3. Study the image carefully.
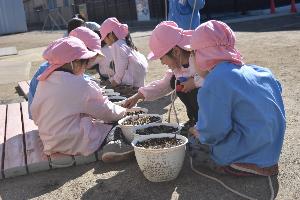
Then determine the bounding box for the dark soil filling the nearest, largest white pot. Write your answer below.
[136,137,183,149]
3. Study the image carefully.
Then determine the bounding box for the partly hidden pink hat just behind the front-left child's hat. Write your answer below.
[69,26,103,56]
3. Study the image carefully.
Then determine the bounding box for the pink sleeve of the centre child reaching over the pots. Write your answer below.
[139,70,174,101]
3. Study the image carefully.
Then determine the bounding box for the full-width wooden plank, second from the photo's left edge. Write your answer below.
[4,103,27,178]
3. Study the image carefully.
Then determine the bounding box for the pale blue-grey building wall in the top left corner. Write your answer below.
[0,0,27,35]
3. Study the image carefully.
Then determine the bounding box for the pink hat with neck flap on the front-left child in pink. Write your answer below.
[38,36,97,81]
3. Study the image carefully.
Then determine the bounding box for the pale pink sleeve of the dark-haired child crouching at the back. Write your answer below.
[109,41,129,84]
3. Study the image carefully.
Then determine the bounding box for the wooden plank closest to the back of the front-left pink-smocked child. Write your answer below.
[21,102,50,173]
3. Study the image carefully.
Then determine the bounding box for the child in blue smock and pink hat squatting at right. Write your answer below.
[191,20,286,176]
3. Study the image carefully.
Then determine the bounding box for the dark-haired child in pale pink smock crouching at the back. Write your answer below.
[100,17,148,87]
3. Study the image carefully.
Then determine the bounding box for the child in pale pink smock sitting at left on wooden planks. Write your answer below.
[30,36,132,161]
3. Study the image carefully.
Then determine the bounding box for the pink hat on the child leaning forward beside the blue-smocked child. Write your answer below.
[148,21,192,60]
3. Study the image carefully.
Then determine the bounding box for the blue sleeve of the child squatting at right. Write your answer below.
[196,87,232,145]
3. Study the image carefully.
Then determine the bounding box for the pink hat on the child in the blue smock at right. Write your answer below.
[191,20,244,71]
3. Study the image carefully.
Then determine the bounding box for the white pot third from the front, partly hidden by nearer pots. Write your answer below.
[118,114,162,142]
